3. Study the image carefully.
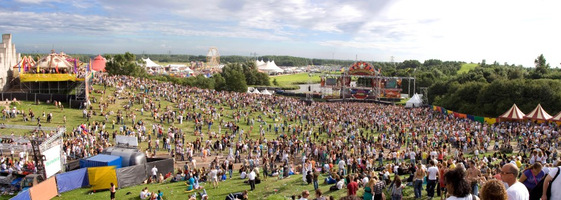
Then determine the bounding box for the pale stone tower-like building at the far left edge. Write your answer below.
[0,34,20,91]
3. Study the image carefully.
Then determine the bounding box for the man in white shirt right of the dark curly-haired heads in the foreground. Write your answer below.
[501,163,530,200]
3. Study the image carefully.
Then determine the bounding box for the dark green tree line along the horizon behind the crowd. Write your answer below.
[24,52,561,117]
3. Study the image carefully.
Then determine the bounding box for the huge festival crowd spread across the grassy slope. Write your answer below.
[1,75,561,199]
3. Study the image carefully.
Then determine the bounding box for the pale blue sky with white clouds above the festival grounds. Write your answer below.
[0,0,561,67]
